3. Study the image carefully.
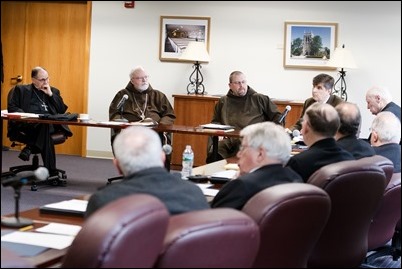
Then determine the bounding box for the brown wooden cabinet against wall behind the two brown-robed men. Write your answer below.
[171,94,303,166]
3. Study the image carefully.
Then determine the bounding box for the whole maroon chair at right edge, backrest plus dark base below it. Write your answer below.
[366,173,401,263]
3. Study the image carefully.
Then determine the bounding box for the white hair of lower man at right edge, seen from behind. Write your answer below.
[371,111,401,144]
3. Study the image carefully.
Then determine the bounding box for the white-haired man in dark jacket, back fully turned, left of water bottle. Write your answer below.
[86,126,209,217]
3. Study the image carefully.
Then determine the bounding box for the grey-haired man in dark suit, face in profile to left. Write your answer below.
[211,122,303,210]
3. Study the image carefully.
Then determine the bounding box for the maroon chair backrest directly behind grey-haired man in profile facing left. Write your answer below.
[242,183,331,268]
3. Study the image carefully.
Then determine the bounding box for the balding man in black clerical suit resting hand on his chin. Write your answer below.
[7,66,72,176]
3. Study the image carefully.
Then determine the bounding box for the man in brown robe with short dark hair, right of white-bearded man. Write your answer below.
[206,71,284,163]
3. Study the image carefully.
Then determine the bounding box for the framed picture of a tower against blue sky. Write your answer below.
[283,21,338,70]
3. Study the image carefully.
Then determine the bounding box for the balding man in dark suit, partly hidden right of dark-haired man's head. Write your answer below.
[335,102,376,159]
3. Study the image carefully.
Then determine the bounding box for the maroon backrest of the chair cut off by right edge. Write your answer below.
[368,173,401,251]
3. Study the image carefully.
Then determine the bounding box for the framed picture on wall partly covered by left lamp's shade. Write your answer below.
[159,16,211,62]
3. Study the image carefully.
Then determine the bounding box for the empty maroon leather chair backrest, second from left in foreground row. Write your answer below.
[155,208,260,268]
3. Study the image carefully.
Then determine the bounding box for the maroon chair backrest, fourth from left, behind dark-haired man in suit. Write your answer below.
[307,159,387,267]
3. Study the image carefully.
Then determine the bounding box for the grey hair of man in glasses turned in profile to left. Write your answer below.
[240,121,292,164]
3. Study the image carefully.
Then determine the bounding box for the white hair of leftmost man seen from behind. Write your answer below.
[113,126,164,176]
